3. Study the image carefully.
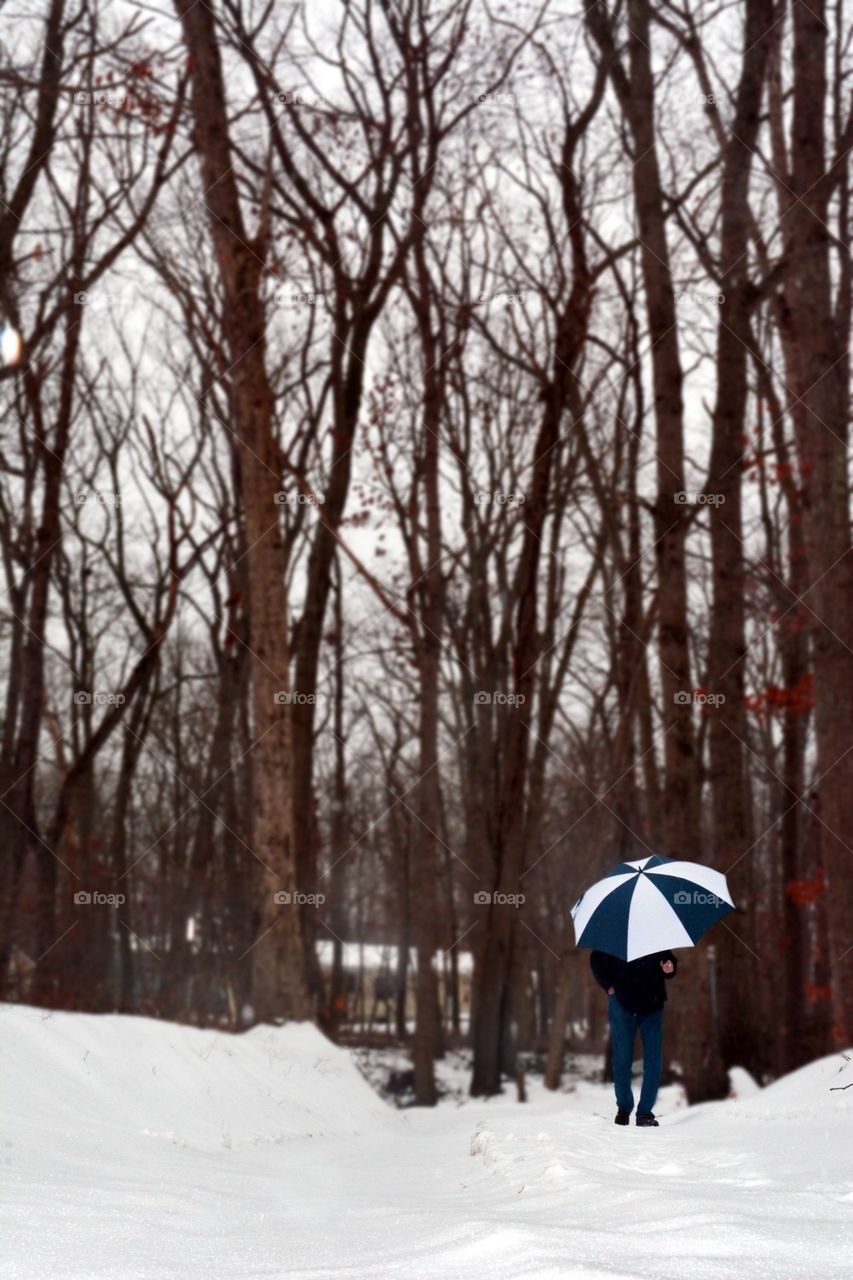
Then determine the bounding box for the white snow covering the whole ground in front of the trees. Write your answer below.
[0,1005,853,1280]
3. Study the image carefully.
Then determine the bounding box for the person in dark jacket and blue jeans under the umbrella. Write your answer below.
[589,951,679,1128]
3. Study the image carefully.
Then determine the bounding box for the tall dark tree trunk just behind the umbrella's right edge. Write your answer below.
[706,0,772,1097]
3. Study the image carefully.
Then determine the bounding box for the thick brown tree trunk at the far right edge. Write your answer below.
[785,0,853,1048]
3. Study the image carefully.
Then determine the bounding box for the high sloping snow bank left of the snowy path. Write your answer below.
[0,1005,394,1151]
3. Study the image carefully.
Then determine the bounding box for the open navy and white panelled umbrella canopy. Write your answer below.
[571,854,734,960]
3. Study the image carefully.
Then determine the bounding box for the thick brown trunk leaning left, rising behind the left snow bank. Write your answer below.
[175,0,311,1021]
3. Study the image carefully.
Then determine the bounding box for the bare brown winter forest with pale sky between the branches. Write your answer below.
[0,0,853,1106]
